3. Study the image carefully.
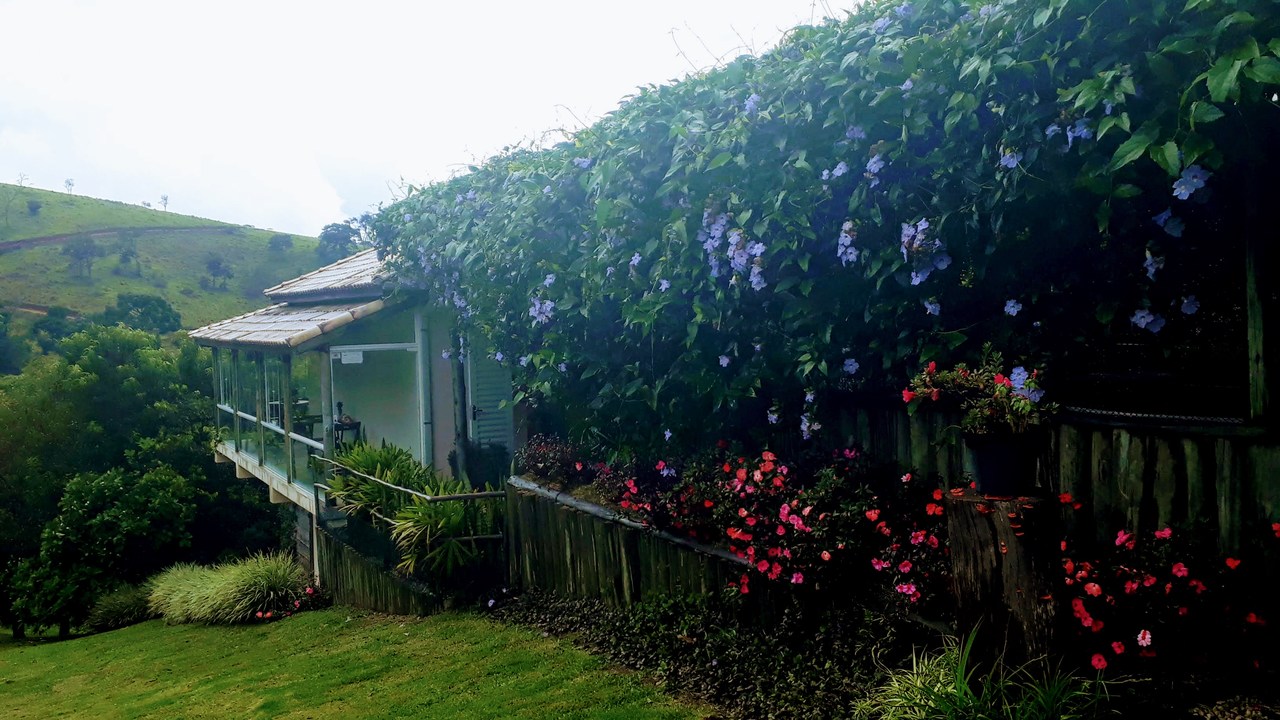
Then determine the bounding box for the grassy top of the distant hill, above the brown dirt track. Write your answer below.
[0,183,228,243]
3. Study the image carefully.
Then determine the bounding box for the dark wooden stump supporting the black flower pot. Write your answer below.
[947,491,1061,669]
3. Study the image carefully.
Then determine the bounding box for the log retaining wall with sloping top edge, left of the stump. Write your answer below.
[507,478,755,607]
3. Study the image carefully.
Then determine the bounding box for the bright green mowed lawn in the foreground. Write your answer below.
[0,607,705,720]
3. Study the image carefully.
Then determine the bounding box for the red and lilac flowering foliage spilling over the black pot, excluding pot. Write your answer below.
[902,345,1057,434]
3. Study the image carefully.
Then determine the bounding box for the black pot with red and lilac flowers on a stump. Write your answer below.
[902,345,1057,496]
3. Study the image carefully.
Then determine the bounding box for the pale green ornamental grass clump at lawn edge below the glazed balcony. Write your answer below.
[150,553,309,625]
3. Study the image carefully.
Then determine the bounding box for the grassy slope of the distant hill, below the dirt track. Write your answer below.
[0,225,320,328]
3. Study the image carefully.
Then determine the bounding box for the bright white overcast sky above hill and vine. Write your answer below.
[0,0,851,234]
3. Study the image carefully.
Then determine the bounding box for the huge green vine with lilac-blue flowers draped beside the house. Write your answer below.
[376,0,1280,454]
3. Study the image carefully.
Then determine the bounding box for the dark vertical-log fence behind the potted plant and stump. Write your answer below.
[842,407,1280,552]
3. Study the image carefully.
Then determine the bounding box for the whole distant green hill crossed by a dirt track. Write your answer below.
[0,183,321,328]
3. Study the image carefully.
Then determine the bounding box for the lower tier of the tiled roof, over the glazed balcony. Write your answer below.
[191,298,384,350]
